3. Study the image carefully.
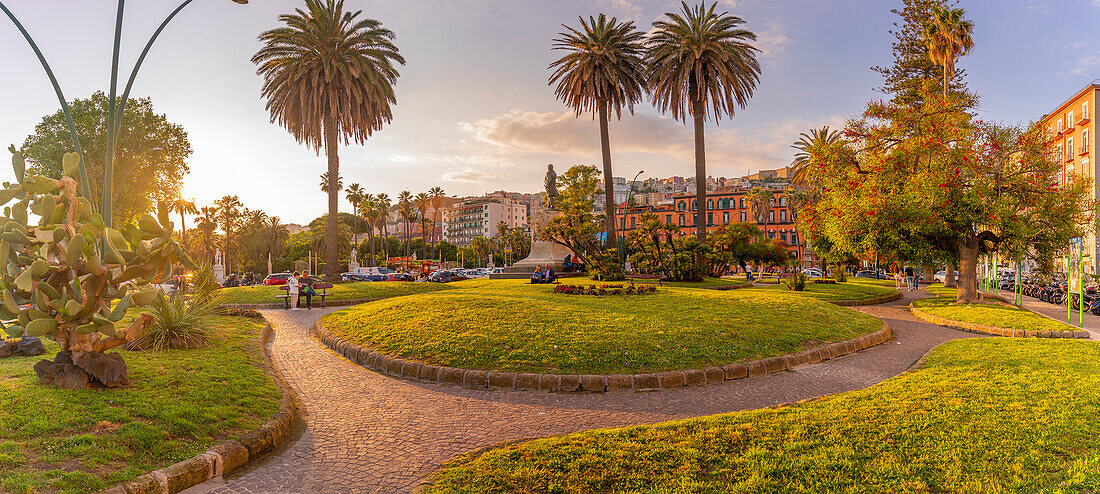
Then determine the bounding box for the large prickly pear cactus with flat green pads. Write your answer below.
[0,146,190,385]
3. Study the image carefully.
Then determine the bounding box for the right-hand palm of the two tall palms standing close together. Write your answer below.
[646,2,760,242]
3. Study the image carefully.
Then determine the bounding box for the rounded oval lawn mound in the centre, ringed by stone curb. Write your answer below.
[325,279,882,374]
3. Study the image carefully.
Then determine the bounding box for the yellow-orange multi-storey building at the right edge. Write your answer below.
[1040,79,1100,274]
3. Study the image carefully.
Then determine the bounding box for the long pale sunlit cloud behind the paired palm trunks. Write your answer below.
[461,110,844,176]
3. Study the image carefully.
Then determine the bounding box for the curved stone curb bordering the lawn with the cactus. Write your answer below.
[100,321,301,494]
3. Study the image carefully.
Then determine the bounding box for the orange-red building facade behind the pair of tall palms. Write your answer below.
[615,189,820,266]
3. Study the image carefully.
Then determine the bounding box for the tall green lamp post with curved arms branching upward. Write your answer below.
[0,0,249,227]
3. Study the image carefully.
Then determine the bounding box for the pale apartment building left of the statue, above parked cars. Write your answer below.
[442,193,528,246]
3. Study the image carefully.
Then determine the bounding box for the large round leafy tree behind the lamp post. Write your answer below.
[20,91,191,224]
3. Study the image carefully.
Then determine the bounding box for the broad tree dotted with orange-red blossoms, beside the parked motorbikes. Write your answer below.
[800,90,1097,303]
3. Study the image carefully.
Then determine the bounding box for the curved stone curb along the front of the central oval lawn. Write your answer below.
[309,319,891,393]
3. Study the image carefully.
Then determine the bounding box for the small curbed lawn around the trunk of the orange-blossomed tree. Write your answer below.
[913,286,1078,331]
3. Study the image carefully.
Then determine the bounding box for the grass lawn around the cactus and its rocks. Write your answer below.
[0,317,282,493]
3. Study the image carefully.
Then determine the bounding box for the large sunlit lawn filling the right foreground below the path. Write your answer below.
[427,336,1100,494]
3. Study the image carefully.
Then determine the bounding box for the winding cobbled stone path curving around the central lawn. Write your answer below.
[185,293,978,494]
